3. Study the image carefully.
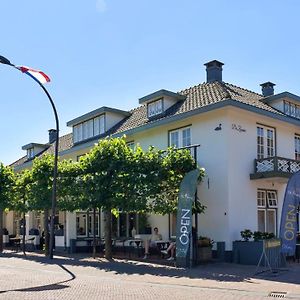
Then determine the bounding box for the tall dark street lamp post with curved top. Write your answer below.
[0,55,59,259]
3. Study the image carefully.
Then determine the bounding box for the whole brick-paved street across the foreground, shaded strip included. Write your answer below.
[0,252,300,300]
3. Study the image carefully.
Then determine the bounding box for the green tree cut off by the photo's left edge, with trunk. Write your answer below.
[0,163,15,252]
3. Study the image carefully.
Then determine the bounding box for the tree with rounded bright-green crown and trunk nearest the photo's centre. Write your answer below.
[79,138,134,259]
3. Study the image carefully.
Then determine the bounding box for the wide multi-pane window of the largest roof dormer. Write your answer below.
[73,114,105,143]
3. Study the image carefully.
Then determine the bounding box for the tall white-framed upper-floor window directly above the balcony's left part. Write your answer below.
[257,126,275,159]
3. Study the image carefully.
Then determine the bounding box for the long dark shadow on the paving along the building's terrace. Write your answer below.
[2,253,300,284]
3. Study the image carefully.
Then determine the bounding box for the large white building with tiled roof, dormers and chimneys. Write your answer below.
[7,60,300,258]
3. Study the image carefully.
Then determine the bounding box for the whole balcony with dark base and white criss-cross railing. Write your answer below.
[250,156,300,179]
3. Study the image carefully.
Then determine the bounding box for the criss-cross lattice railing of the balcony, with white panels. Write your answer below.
[254,156,300,174]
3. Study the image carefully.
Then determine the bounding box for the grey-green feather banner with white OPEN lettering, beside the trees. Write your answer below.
[176,169,200,267]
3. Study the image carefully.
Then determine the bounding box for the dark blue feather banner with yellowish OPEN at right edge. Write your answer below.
[280,171,300,256]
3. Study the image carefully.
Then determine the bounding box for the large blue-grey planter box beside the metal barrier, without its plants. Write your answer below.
[232,241,263,265]
